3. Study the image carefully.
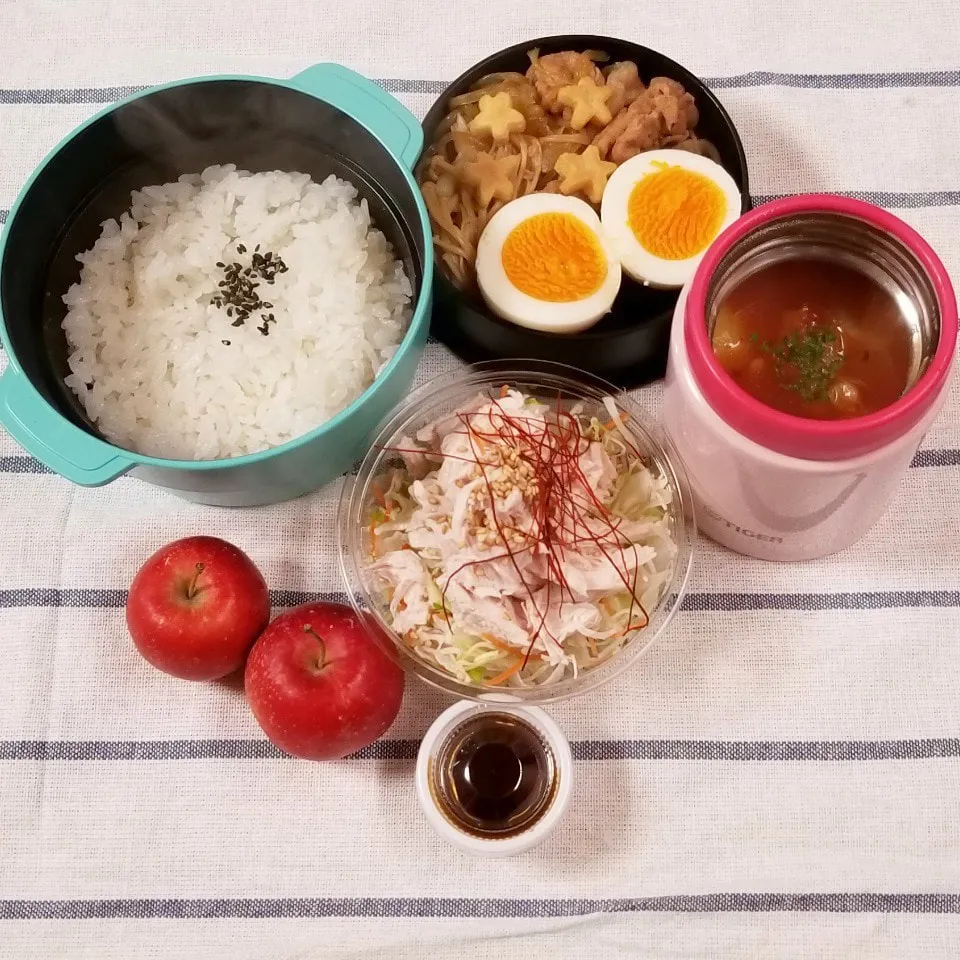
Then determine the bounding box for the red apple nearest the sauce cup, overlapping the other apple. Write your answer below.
[244,603,403,760]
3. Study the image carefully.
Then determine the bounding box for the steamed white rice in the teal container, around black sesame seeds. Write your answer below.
[63,165,412,460]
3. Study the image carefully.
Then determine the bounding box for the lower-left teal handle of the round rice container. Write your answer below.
[0,367,133,487]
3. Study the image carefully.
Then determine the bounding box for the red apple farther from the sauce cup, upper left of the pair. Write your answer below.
[127,537,270,680]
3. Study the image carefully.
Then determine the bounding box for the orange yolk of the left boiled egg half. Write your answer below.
[500,213,607,303]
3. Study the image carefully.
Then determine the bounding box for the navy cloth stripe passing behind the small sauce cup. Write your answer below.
[0,737,960,763]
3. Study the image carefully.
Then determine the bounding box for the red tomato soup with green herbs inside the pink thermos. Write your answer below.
[712,258,913,420]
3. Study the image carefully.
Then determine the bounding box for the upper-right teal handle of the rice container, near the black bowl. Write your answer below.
[290,63,423,170]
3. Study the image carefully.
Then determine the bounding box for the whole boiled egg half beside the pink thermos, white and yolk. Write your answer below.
[600,150,741,287]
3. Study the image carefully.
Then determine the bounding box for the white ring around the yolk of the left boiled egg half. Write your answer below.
[476,193,621,333]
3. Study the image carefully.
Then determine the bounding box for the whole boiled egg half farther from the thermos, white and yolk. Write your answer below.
[477,193,621,333]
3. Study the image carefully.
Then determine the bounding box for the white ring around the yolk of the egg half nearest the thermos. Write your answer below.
[600,150,741,288]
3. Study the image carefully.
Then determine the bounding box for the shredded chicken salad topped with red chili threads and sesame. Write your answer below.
[371,390,676,685]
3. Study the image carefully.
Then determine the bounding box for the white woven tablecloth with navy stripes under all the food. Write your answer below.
[0,0,960,960]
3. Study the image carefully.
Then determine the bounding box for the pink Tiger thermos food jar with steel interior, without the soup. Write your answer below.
[663,195,957,560]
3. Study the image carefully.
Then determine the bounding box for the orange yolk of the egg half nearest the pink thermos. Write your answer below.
[627,164,727,260]
